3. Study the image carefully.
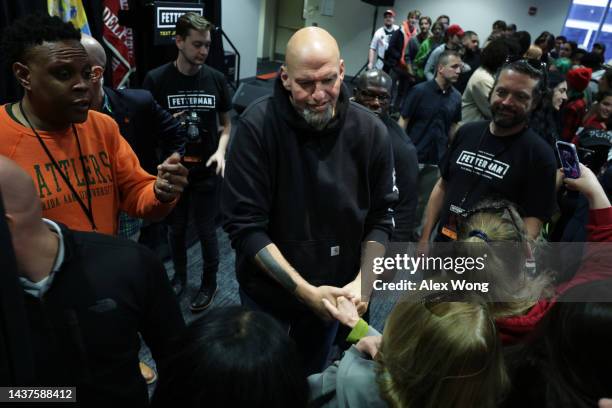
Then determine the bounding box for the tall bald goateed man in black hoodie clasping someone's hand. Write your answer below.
[221,27,397,373]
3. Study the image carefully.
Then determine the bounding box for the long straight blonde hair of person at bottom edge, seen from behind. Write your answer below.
[377,301,509,408]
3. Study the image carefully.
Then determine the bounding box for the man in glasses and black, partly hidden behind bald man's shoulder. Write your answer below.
[353,69,419,242]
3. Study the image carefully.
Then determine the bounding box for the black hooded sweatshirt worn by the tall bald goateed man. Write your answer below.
[221,79,396,314]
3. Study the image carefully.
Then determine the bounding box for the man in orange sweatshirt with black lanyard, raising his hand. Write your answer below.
[0,16,188,234]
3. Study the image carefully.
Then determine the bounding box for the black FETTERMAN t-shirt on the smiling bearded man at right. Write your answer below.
[439,121,557,236]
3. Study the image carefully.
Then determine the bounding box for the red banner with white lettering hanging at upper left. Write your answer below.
[102,0,136,88]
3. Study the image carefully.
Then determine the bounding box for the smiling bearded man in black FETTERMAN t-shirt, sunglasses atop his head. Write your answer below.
[421,60,557,248]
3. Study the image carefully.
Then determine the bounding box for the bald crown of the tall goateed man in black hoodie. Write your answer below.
[285,27,340,72]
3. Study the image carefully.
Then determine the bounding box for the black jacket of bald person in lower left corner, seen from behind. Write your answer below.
[24,226,185,407]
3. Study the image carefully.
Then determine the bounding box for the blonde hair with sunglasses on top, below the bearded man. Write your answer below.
[458,200,554,318]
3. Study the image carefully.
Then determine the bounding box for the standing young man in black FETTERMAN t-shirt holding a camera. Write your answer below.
[143,13,231,312]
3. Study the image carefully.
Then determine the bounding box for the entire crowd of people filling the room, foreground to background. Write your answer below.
[0,10,612,408]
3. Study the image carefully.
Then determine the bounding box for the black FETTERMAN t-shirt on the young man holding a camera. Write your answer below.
[143,62,231,176]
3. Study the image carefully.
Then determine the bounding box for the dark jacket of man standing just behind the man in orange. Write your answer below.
[104,86,185,175]
